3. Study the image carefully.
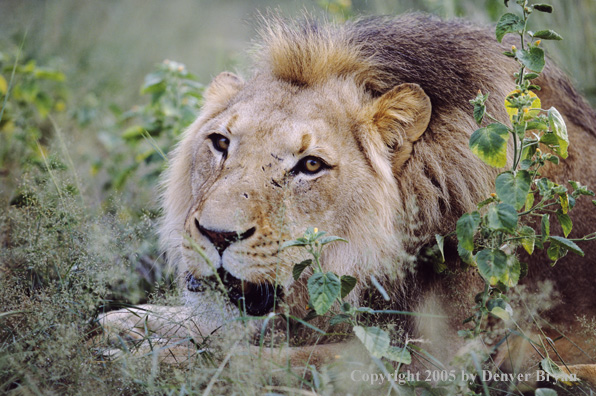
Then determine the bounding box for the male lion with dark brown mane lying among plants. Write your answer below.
[102,14,596,381]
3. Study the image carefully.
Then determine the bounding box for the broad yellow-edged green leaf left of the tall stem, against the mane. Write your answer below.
[470,123,509,168]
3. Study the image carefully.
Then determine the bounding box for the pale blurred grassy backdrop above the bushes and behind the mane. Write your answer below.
[0,0,596,105]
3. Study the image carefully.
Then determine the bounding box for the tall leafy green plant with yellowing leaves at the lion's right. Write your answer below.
[436,0,596,384]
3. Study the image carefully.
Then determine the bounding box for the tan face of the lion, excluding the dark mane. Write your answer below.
[166,73,429,314]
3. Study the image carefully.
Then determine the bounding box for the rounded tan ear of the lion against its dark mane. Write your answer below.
[372,84,432,171]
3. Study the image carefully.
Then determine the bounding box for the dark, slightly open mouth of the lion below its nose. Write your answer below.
[186,267,282,316]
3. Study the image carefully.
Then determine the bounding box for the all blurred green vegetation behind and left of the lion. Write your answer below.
[0,0,596,394]
